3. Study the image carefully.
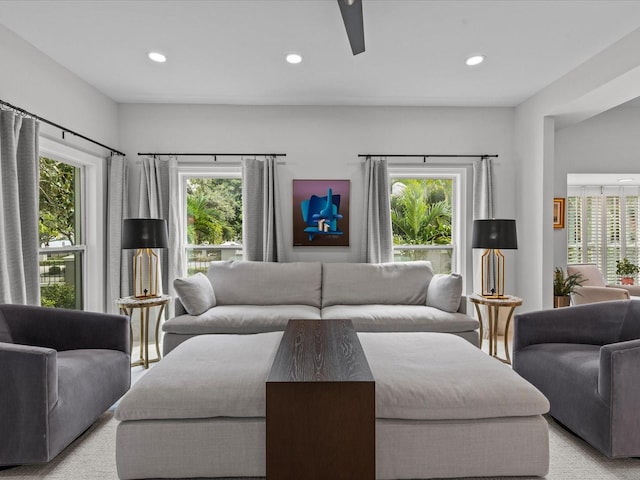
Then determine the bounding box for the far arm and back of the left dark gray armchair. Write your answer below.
[0,305,130,353]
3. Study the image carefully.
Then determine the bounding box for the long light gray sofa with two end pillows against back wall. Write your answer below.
[162,261,479,355]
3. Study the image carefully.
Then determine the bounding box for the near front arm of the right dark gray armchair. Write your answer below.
[598,340,640,457]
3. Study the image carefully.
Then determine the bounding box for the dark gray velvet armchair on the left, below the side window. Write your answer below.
[0,305,131,466]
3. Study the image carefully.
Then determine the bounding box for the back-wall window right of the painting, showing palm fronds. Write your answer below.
[389,167,465,273]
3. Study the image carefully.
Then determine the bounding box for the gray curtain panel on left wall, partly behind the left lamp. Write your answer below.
[105,154,132,313]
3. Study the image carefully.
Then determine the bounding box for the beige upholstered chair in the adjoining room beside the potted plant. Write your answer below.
[567,263,640,305]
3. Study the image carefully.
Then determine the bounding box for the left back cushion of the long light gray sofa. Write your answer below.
[207,261,322,308]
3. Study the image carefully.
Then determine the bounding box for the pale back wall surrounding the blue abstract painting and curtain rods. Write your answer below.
[119,104,517,284]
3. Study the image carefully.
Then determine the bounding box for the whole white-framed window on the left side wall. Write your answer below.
[39,139,105,312]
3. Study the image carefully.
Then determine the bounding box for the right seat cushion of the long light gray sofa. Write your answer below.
[322,304,480,333]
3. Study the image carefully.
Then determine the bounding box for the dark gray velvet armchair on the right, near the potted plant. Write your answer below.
[513,300,640,458]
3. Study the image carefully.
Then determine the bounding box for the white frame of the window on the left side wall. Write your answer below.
[38,135,106,312]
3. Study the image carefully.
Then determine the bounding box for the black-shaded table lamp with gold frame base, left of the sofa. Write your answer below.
[122,218,169,298]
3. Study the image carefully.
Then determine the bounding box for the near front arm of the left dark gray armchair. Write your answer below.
[0,343,58,465]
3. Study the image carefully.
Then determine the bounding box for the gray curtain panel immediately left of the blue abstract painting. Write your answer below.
[242,157,284,262]
